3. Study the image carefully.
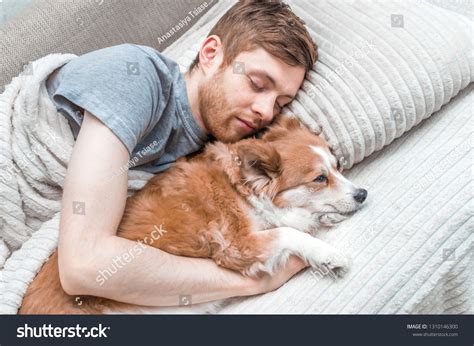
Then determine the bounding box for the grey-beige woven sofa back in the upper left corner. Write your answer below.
[0,0,217,92]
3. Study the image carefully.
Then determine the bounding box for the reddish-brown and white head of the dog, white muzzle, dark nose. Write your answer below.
[234,116,367,224]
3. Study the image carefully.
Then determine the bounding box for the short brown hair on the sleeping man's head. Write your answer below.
[189,0,318,72]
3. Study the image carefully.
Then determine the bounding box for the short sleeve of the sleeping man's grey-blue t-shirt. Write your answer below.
[54,44,167,155]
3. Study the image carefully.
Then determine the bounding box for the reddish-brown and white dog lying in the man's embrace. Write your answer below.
[19,116,367,314]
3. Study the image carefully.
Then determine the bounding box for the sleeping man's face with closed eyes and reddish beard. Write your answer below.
[198,48,305,142]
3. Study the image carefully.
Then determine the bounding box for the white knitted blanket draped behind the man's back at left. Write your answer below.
[0,54,152,314]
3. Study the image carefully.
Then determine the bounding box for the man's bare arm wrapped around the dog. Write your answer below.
[59,111,305,306]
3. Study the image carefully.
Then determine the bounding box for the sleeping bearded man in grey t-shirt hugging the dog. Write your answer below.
[51,1,317,306]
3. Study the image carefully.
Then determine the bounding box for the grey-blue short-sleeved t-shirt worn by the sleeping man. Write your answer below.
[46,44,208,173]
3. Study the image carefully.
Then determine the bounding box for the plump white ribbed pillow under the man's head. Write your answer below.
[165,0,474,169]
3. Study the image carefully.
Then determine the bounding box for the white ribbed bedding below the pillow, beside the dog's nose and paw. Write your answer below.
[221,84,474,314]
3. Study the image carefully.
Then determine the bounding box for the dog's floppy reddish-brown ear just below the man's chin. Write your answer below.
[237,141,282,198]
